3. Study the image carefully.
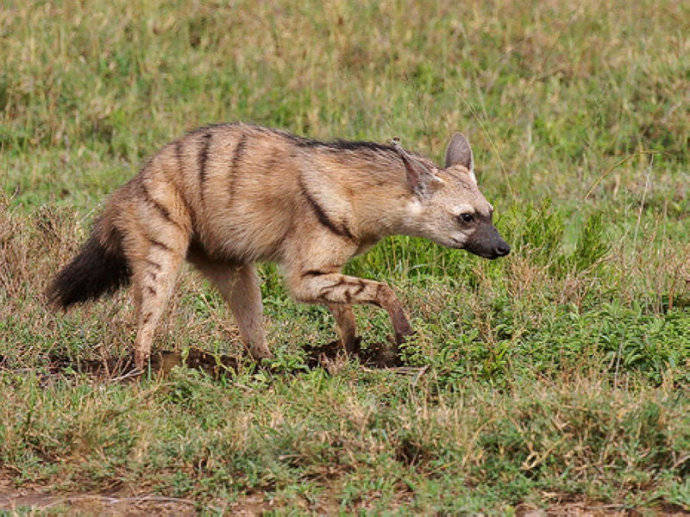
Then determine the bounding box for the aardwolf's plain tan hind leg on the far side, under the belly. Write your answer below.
[192,257,273,361]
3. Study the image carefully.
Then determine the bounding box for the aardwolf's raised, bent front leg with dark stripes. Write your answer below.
[288,270,412,344]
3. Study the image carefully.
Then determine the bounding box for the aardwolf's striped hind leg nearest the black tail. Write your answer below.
[130,237,186,370]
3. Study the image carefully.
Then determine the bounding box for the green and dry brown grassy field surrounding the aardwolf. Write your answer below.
[0,0,690,513]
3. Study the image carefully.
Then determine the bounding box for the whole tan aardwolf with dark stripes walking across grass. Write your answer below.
[48,123,510,369]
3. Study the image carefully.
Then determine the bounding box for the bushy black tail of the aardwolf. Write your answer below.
[47,224,131,309]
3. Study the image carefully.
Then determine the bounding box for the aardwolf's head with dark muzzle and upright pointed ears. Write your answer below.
[393,133,510,259]
